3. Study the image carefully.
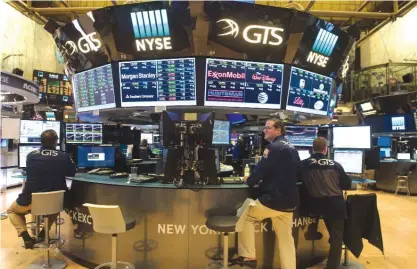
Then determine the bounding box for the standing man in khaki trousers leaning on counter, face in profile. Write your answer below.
[238,118,301,269]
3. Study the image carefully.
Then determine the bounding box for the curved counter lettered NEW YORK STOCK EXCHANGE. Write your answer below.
[61,174,329,269]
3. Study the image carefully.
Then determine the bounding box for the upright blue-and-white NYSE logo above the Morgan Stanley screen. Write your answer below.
[130,9,172,51]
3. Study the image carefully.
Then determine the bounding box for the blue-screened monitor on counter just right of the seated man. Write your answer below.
[77,146,116,168]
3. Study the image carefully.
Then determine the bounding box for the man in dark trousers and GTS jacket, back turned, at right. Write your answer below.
[302,137,352,269]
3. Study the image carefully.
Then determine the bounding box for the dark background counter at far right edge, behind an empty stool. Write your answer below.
[375,160,417,195]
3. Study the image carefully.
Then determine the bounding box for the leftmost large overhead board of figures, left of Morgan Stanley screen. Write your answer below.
[73,64,116,112]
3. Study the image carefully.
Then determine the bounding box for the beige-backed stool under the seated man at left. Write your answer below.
[28,190,67,269]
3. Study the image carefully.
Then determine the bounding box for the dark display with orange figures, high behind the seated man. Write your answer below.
[33,70,73,105]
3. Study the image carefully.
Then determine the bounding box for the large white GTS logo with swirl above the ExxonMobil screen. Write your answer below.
[216,19,284,46]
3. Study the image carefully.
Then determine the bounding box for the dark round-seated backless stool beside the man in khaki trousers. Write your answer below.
[206,216,239,269]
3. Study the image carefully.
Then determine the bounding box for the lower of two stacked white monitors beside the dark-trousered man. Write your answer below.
[334,149,363,174]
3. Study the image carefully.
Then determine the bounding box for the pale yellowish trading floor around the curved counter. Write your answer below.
[0,188,417,269]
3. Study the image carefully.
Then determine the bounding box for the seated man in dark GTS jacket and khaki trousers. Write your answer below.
[7,130,76,248]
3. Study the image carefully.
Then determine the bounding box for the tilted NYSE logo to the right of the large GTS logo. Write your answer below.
[307,29,339,67]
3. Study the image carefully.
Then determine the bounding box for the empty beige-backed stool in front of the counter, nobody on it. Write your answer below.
[83,203,136,269]
